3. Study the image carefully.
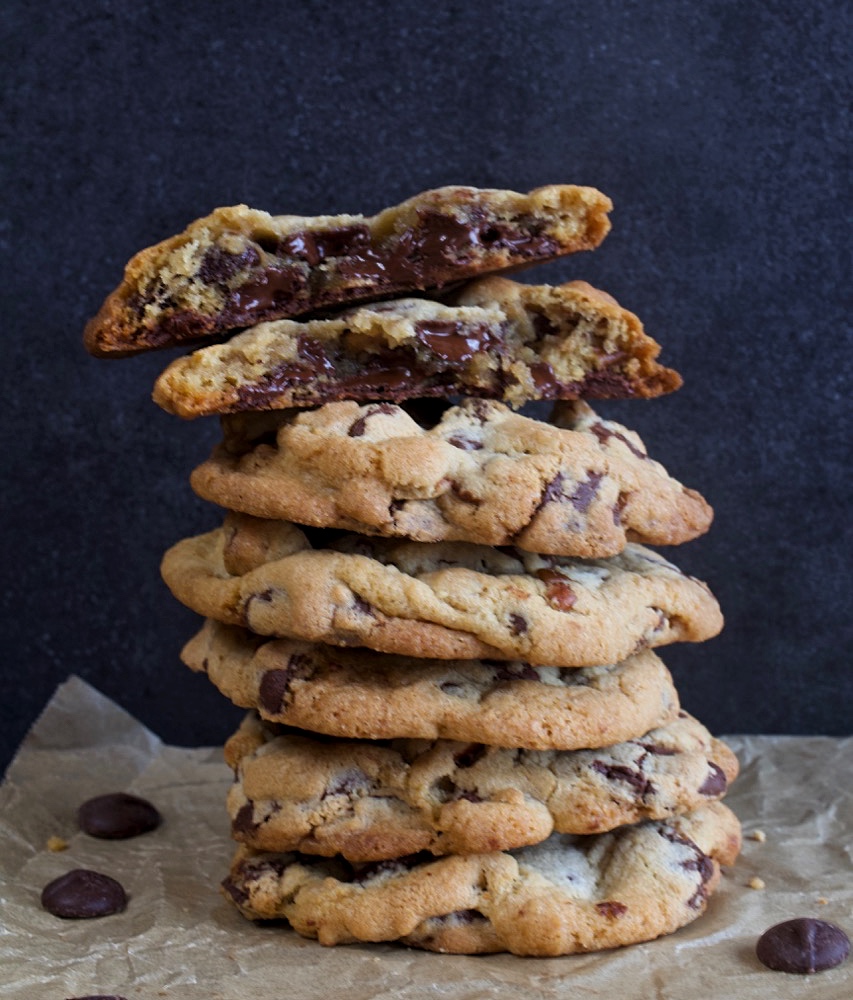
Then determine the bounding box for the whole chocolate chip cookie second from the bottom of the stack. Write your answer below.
[225,714,737,861]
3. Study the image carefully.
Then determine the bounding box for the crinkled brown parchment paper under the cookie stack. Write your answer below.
[0,677,853,1000]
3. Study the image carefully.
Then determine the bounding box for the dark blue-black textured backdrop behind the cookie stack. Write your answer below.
[0,0,853,763]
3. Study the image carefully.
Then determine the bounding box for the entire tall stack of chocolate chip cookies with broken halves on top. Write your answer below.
[86,185,740,955]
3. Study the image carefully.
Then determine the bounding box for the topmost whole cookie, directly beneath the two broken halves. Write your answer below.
[191,399,713,558]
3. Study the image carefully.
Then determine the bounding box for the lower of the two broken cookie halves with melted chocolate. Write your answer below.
[148,278,681,418]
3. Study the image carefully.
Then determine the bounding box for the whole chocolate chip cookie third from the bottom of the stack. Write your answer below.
[181,620,679,750]
